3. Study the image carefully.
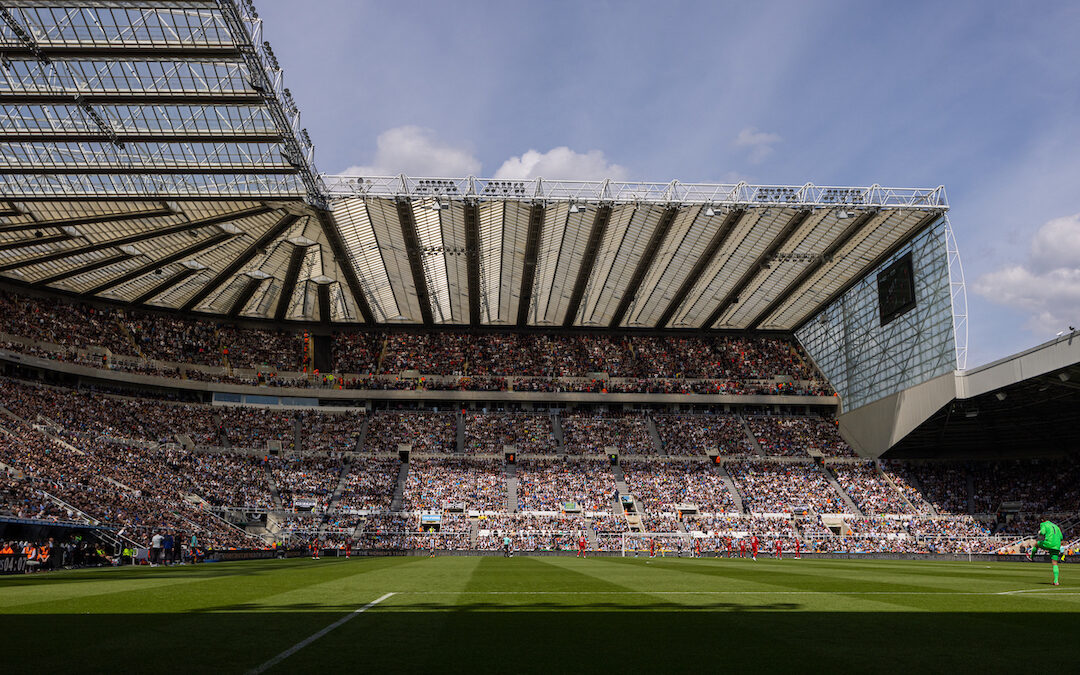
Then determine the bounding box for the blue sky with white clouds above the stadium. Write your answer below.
[257,0,1080,366]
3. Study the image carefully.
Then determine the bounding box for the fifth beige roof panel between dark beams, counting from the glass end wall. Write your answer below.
[575,204,664,326]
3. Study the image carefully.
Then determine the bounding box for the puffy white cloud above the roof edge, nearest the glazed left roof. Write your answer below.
[343,126,481,177]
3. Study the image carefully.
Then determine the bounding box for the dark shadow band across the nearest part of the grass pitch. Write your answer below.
[0,603,1080,674]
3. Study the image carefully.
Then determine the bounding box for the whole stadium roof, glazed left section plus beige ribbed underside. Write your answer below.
[0,0,948,330]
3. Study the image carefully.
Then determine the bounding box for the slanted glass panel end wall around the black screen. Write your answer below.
[795,218,956,410]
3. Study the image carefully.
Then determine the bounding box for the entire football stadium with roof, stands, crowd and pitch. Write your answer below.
[0,0,1080,673]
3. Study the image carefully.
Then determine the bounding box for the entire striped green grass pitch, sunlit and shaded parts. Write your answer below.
[0,556,1080,673]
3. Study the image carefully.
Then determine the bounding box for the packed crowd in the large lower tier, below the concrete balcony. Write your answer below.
[0,371,1080,551]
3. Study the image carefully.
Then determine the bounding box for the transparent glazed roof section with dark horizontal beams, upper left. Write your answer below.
[0,0,318,199]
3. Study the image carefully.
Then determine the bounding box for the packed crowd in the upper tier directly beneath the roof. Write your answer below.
[0,291,832,395]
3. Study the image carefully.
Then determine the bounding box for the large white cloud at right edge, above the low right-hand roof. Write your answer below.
[973,214,1080,337]
